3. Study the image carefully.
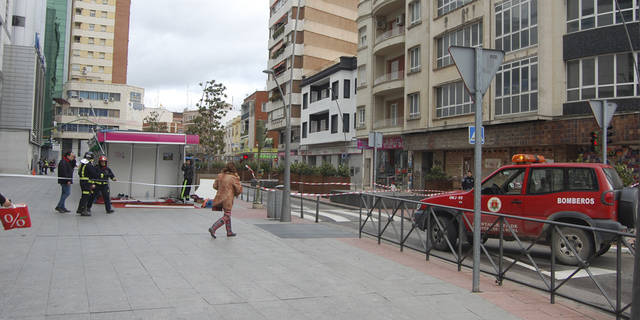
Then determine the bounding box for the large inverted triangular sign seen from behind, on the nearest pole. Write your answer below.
[449,46,504,98]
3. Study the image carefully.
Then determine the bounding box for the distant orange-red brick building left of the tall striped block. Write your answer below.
[240,91,279,159]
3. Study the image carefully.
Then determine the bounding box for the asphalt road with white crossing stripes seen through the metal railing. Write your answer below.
[291,194,634,316]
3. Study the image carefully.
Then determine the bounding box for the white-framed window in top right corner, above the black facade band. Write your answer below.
[567,0,640,33]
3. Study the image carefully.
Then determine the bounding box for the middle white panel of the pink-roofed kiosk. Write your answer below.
[131,144,156,200]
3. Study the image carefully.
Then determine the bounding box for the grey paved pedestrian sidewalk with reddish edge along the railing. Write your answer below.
[0,177,610,320]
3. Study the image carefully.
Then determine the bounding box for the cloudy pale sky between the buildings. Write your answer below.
[128,0,269,117]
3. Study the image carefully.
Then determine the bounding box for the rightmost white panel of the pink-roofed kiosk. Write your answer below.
[156,145,183,198]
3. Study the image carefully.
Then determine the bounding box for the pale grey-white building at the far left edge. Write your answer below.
[0,0,46,173]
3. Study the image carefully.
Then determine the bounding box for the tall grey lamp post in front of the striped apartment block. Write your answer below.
[280,0,300,222]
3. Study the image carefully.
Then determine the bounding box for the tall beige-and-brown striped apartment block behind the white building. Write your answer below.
[266,0,358,164]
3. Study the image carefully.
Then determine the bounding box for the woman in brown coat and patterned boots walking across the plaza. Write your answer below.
[209,162,242,239]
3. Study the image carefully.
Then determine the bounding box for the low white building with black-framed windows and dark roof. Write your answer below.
[300,57,362,173]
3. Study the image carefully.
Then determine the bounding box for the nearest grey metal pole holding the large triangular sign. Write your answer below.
[472,48,482,292]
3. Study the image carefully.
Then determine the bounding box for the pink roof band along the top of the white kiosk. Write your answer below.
[98,131,200,145]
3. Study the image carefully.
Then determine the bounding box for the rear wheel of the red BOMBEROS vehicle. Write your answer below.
[552,227,594,266]
